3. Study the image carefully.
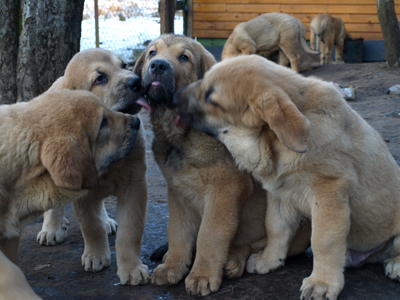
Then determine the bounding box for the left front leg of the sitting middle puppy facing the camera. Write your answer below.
[150,186,200,285]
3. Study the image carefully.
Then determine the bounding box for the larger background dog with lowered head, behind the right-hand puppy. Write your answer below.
[222,13,320,72]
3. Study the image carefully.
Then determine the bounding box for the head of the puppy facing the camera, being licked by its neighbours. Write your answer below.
[133,34,216,108]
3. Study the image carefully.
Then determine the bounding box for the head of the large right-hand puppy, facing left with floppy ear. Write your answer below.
[174,55,310,152]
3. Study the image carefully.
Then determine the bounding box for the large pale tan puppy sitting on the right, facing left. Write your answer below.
[174,55,400,300]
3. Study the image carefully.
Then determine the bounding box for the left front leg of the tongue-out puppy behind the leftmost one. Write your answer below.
[72,193,110,272]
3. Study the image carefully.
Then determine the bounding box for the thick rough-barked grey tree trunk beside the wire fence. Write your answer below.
[17,0,84,102]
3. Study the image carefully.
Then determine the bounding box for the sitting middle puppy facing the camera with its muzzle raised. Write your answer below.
[134,34,310,296]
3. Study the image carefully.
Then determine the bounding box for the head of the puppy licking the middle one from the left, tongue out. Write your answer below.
[49,48,142,114]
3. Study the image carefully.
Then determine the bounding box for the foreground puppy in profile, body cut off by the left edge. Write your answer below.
[0,90,140,299]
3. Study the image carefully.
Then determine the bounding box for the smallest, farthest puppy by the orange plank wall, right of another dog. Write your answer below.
[310,14,351,65]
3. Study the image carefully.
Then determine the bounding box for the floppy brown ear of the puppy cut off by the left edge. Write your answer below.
[40,137,98,191]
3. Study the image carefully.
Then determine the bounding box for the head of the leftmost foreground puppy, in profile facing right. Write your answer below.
[39,90,140,190]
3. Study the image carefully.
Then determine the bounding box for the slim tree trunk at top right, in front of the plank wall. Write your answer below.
[377,0,400,68]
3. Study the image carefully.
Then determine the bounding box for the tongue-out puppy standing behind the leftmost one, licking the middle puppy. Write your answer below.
[38,49,150,285]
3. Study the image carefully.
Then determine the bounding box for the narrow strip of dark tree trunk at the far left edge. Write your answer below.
[0,0,19,104]
